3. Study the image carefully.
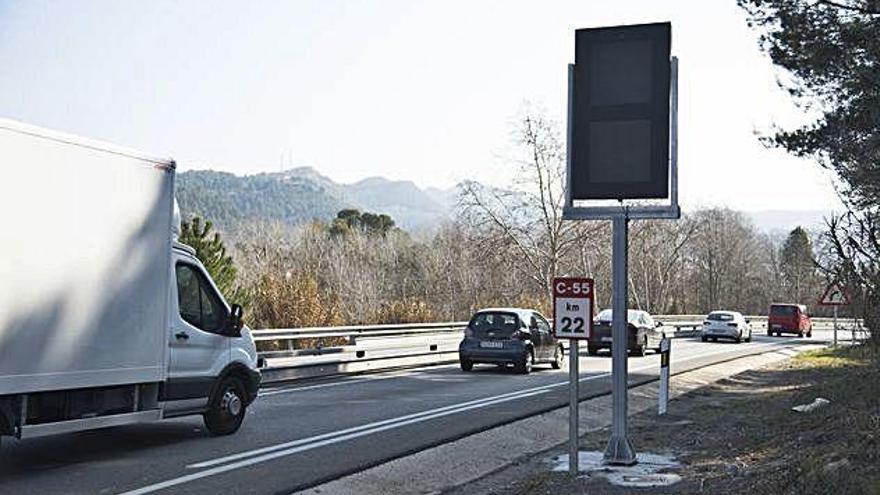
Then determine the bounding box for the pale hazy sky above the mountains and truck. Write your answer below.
[0,0,837,210]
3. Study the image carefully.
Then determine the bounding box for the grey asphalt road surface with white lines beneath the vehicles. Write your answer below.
[0,331,844,495]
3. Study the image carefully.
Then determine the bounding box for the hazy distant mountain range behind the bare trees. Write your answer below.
[177,167,830,235]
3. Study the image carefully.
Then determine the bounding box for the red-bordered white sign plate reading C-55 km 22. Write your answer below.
[553,277,595,339]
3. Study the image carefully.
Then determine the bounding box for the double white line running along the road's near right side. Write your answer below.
[120,338,800,495]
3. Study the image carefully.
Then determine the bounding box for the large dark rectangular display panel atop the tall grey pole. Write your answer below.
[569,22,672,200]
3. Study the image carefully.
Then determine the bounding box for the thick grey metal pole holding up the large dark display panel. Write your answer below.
[604,213,636,466]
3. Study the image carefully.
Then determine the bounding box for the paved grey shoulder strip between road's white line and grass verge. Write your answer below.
[299,349,824,495]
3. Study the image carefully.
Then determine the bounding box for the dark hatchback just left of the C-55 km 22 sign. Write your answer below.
[458,308,565,373]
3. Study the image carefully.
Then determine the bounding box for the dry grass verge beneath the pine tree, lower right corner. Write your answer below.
[450,346,880,495]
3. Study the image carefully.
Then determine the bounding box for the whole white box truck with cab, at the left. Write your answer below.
[0,119,260,448]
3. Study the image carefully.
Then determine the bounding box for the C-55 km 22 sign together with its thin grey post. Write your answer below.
[553,278,594,477]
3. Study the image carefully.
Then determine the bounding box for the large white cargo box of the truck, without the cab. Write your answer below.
[0,119,174,395]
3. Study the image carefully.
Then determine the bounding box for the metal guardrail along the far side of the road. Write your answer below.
[253,315,853,383]
